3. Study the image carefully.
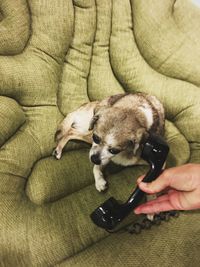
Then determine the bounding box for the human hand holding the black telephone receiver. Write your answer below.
[134,164,200,214]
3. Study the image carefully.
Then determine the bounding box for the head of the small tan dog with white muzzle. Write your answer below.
[90,106,148,165]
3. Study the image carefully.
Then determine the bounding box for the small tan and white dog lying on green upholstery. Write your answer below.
[53,93,165,194]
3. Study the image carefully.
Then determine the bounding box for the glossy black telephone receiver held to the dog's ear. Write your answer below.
[90,134,169,231]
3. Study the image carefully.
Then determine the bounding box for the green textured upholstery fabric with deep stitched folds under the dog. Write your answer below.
[0,0,200,267]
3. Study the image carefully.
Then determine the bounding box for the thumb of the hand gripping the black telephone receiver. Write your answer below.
[138,172,170,194]
